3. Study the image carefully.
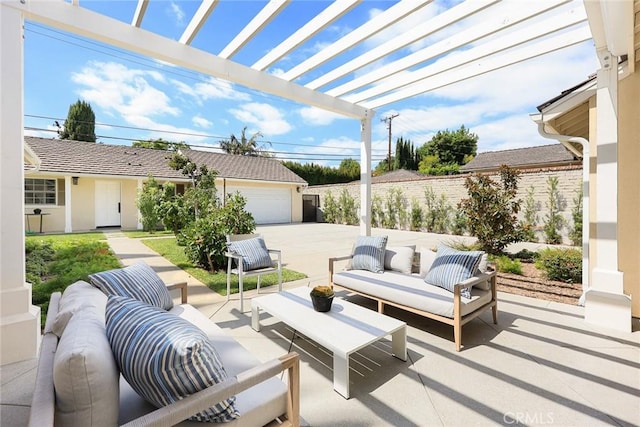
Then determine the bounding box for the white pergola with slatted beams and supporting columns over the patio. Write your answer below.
[0,0,635,364]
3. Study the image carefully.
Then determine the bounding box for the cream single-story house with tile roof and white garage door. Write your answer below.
[24,136,307,232]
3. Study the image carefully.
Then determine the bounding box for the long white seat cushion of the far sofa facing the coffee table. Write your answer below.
[333,270,491,318]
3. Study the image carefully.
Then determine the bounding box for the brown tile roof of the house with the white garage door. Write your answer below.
[24,136,306,184]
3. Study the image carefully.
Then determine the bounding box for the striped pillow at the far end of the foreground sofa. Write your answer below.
[89,262,173,310]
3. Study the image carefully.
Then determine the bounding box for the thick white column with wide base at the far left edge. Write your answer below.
[0,3,40,365]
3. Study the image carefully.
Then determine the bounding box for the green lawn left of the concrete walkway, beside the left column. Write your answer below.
[25,232,120,326]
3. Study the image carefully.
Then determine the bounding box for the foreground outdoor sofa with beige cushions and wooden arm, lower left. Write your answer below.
[29,264,299,427]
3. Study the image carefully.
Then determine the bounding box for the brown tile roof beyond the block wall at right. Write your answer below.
[460,144,581,172]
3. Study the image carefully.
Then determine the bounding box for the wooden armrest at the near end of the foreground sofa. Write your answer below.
[125,352,300,427]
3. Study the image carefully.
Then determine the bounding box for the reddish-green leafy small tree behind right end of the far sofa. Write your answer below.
[458,165,522,254]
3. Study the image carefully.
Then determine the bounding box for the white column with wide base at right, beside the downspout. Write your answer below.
[585,49,631,332]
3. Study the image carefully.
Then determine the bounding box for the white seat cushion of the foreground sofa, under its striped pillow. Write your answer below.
[119,304,287,427]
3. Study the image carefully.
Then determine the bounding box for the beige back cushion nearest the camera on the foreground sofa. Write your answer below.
[53,308,120,426]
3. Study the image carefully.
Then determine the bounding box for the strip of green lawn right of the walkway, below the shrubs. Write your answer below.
[143,238,307,295]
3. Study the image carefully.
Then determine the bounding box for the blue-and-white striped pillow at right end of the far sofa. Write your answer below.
[424,245,484,298]
